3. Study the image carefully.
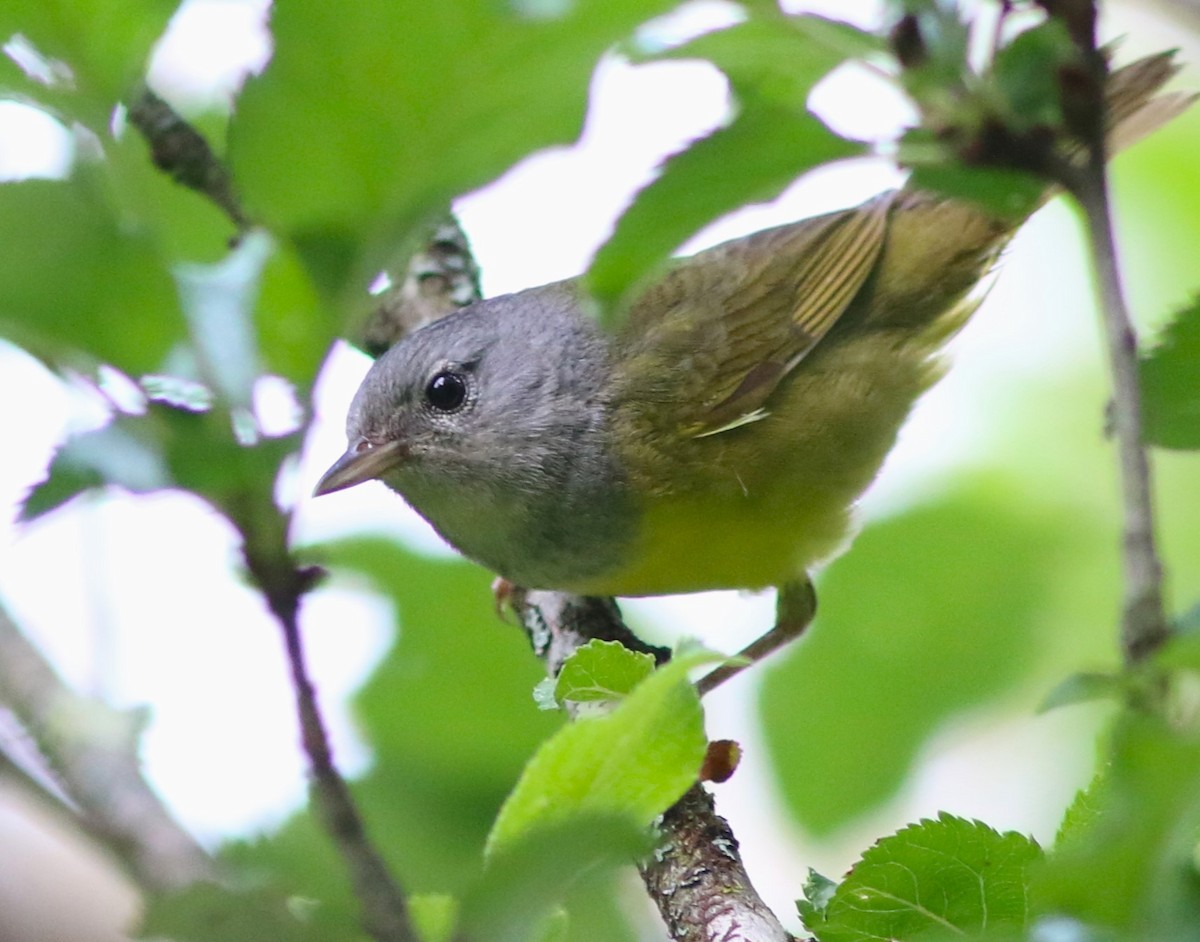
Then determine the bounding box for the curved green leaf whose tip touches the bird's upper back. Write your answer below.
[586,101,860,320]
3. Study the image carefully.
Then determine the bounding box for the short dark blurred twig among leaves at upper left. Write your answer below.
[128,89,250,233]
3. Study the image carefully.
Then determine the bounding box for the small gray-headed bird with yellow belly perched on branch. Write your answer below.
[314,55,1175,685]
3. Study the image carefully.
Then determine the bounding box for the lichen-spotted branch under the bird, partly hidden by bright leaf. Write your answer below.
[509,589,793,942]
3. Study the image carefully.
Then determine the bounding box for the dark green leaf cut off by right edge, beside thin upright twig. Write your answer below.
[1139,299,1200,449]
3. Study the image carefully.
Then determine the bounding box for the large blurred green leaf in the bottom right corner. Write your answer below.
[1033,713,1200,942]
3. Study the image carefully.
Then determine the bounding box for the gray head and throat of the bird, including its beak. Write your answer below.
[317,283,631,588]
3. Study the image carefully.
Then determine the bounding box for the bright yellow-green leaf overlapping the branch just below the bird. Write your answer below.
[487,653,714,856]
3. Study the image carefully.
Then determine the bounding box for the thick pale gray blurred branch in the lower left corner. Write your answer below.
[0,610,215,890]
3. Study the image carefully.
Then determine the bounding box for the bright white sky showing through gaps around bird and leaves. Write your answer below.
[0,0,1180,912]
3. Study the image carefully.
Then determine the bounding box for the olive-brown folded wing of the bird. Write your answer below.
[613,193,894,438]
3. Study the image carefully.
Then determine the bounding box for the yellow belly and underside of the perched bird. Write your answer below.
[566,326,938,595]
